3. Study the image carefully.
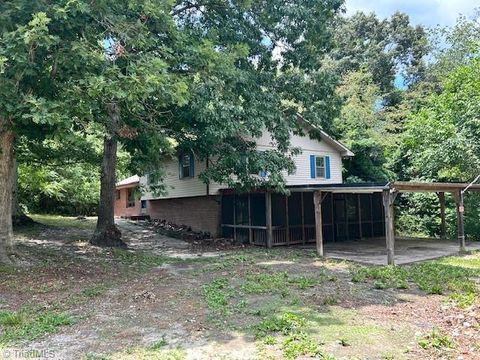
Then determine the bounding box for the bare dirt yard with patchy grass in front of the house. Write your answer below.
[0,219,480,359]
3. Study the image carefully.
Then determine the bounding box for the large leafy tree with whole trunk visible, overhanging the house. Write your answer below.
[66,0,340,245]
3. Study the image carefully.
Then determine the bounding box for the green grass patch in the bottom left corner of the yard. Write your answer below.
[0,309,74,344]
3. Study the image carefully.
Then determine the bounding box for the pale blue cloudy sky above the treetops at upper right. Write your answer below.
[346,0,480,27]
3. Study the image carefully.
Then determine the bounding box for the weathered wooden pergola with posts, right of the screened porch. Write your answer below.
[310,182,480,265]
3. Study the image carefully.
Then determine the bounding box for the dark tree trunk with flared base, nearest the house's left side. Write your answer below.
[90,103,126,247]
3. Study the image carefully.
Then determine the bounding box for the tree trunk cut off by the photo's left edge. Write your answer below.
[0,117,15,263]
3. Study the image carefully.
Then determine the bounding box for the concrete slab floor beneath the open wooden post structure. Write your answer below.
[324,239,480,265]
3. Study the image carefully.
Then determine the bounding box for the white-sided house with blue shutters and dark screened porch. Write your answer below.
[115,123,385,246]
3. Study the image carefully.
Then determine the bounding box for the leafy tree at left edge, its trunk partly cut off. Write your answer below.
[0,1,68,261]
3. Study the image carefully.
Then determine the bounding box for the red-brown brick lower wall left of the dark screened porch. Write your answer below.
[147,196,220,236]
